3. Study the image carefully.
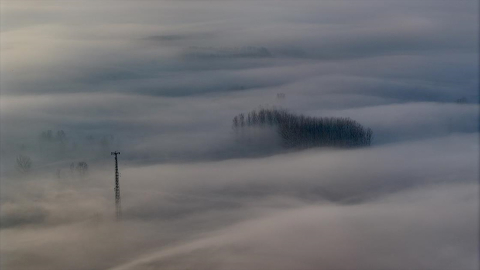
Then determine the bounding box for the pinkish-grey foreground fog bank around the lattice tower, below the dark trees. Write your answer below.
[2,135,478,269]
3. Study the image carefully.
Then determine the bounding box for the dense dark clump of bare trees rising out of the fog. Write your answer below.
[233,109,372,148]
